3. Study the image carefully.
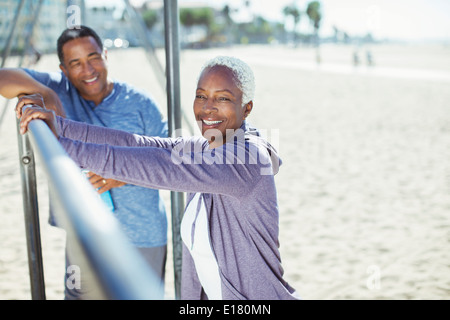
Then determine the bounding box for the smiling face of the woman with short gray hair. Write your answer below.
[194,66,253,149]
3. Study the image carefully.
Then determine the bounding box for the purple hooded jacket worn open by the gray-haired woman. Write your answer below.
[57,117,296,300]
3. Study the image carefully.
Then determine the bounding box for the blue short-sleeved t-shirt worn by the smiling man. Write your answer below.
[24,69,168,247]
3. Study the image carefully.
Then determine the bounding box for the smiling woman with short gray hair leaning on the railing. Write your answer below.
[17,57,296,299]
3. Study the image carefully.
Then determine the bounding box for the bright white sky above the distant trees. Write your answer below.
[102,0,450,41]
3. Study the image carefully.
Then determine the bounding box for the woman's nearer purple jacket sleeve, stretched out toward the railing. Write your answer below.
[60,130,261,198]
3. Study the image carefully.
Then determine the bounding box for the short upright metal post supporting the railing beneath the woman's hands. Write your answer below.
[17,122,45,300]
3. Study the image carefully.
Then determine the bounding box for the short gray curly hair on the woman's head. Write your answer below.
[200,56,255,106]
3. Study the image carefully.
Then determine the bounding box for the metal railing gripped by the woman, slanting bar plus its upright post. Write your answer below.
[19,115,161,300]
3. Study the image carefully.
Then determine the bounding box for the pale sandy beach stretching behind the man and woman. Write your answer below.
[0,45,450,300]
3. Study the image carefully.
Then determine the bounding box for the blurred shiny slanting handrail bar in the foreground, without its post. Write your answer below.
[27,120,161,300]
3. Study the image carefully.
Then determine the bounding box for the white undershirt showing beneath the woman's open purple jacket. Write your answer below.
[180,193,222,300]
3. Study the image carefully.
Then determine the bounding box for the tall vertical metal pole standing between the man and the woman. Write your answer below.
[164,0,184,300]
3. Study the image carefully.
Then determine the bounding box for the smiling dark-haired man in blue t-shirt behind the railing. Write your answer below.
[0,26,167,299]
